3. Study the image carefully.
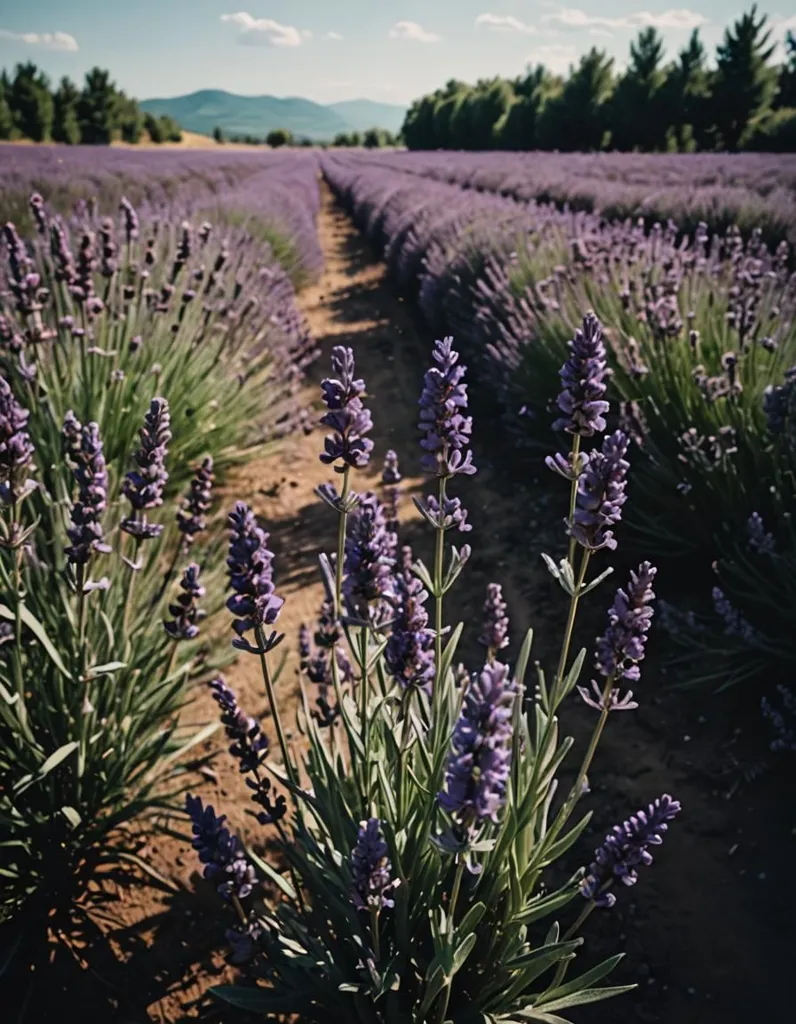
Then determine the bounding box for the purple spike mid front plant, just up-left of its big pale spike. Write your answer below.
[384,565,435,688]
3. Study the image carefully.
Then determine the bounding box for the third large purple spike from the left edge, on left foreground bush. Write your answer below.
[120,398,171,540]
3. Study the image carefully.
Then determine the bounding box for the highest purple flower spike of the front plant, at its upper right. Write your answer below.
[553,312,609,437]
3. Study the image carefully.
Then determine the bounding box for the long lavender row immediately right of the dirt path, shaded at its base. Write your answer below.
[324,149,796,712]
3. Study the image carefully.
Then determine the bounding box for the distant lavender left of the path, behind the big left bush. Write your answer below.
[0,145,323,283]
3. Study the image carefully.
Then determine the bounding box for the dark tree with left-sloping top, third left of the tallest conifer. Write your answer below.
[538,47,614,152]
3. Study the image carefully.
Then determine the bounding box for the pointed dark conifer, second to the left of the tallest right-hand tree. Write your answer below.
[611,28,668,152]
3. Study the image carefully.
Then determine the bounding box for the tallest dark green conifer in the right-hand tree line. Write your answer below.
[712,4,777,151]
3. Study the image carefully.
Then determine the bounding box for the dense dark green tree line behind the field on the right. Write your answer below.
[402,5,796,153]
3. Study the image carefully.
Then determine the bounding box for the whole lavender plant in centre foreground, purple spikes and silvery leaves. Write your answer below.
[187,319,680,1024]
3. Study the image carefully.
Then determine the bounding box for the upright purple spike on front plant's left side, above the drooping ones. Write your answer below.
[226,502,285,650]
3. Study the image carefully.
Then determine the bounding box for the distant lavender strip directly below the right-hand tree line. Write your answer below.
[350,152,796,246]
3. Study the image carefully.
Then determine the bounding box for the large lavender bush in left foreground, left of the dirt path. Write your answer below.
[0,160,318,924]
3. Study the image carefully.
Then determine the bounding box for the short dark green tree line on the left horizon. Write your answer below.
[0,61,182,145]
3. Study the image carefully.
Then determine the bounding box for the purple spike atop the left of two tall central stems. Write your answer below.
[321,345,373,473]
